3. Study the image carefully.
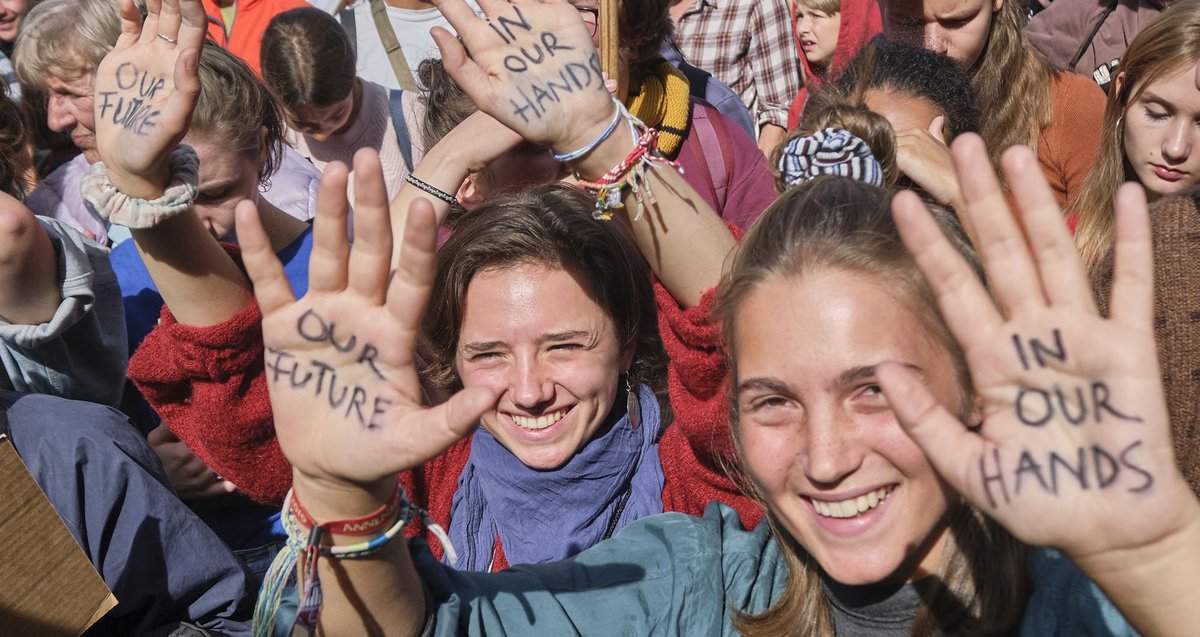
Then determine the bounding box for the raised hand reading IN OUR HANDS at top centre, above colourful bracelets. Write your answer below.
[433,0,613,152]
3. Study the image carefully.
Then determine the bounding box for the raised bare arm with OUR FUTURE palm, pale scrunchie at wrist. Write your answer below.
[95,0,250,326]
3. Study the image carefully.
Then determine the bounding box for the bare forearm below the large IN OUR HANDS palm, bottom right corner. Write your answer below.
[1075,503,1200,637]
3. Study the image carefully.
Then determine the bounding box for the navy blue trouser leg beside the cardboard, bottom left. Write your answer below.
[0,391,256,637]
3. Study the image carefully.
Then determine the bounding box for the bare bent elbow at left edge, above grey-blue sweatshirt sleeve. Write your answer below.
[0,209,62,325]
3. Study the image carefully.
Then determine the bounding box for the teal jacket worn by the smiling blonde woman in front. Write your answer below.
[400,503,1135,637]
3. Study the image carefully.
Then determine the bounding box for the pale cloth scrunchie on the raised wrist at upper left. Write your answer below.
[80,144,200,229]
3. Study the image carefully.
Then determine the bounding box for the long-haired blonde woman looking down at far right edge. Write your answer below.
[1070,0,1200,266]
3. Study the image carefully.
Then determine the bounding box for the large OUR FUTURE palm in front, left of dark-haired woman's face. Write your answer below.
[238,150,496,504]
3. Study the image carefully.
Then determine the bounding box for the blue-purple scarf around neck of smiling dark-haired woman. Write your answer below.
[450,385,662,571]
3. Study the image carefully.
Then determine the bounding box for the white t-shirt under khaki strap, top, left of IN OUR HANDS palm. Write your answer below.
[324,0,482,89]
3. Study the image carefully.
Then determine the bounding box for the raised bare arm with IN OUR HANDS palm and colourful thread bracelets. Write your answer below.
[433,0,734,306]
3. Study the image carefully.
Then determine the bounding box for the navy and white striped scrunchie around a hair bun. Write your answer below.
[779,128,883,186]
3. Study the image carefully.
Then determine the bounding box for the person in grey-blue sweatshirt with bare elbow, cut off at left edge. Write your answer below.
[0,78,128,407]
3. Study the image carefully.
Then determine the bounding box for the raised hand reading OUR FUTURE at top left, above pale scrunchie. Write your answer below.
[95,0,208,199]
